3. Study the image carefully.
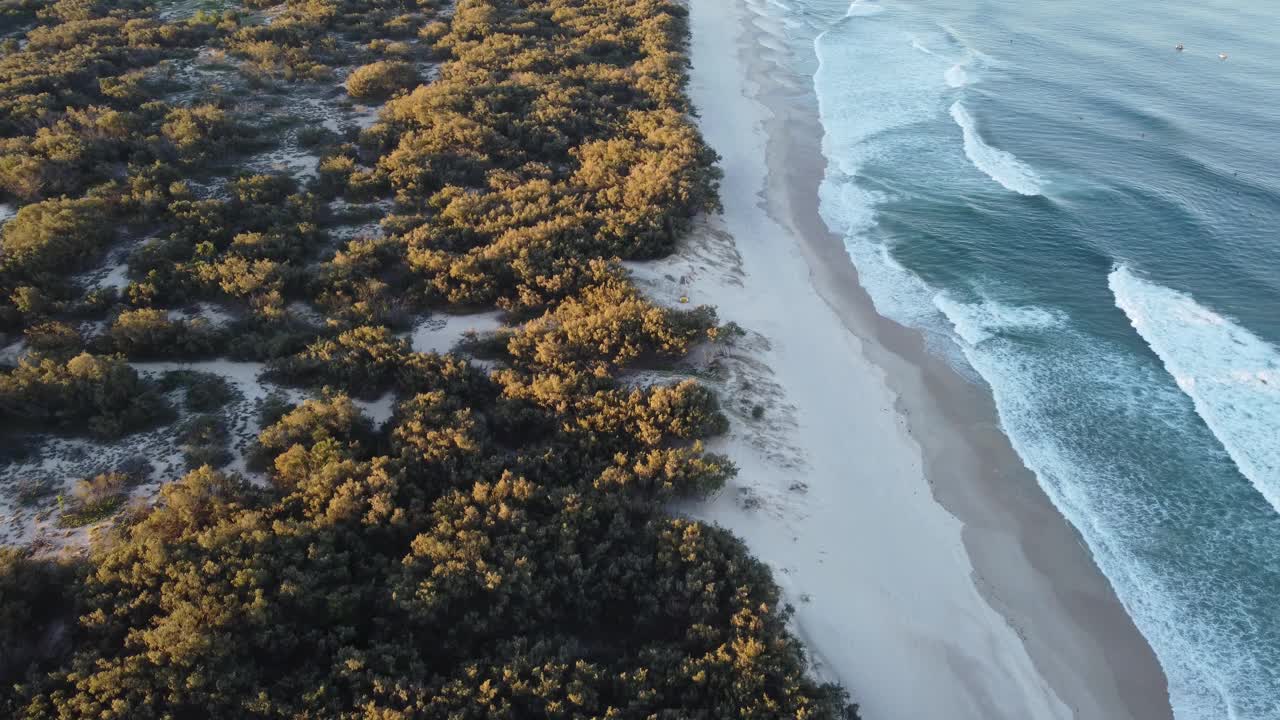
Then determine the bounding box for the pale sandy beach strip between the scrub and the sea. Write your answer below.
[645,0,1171,720]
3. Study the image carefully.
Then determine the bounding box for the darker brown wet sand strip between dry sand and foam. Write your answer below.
[771,70,1172,720]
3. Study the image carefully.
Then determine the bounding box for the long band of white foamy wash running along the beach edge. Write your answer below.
[814,0,1277,707]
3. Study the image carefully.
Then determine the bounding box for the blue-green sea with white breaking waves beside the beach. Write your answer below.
[758,0,1280,720]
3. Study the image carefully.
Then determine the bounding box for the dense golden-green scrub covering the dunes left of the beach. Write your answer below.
[0,0,855,719]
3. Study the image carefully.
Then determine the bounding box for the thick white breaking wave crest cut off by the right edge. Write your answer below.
[1108,265,1280,511]
